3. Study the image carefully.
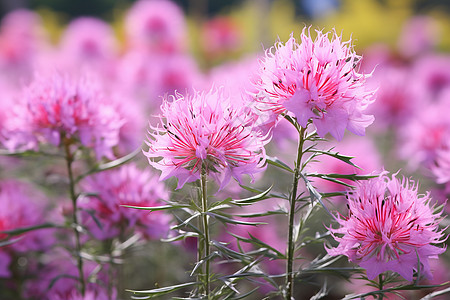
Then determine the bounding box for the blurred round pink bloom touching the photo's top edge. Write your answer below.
[125,0,186,53]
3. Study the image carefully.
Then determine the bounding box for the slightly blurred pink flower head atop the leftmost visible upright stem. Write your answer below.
[24,73,123,159]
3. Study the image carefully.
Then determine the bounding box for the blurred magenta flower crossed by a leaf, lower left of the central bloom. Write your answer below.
[79,164,170,240]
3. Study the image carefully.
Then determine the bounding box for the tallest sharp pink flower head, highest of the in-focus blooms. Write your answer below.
[251,28,374,140]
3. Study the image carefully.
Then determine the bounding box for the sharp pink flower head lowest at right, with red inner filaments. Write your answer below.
[327,173,446,281]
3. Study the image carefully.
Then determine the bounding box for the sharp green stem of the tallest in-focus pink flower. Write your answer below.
[286,127,306,300]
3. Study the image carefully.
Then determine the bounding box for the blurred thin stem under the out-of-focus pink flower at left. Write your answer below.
[64,140,86,296]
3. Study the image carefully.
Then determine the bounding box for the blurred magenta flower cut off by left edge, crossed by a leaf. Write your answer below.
[0,179,54,277]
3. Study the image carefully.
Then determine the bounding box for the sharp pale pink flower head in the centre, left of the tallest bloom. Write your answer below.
[145,89,267,189]
